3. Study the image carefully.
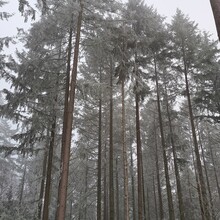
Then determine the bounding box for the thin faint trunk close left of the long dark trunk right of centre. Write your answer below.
[154,120,164,220]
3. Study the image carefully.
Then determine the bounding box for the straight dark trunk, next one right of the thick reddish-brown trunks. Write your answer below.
[97,69,102,220]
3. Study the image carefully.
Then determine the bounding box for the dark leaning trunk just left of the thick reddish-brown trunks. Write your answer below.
[42,115,57,220]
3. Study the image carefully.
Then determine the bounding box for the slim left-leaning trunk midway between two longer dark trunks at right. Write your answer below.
[165,82,185,220]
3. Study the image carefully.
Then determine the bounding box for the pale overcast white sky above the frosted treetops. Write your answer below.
[0,0,217,40]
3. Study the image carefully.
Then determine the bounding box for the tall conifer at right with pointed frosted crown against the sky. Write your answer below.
[171,10,210,219]
